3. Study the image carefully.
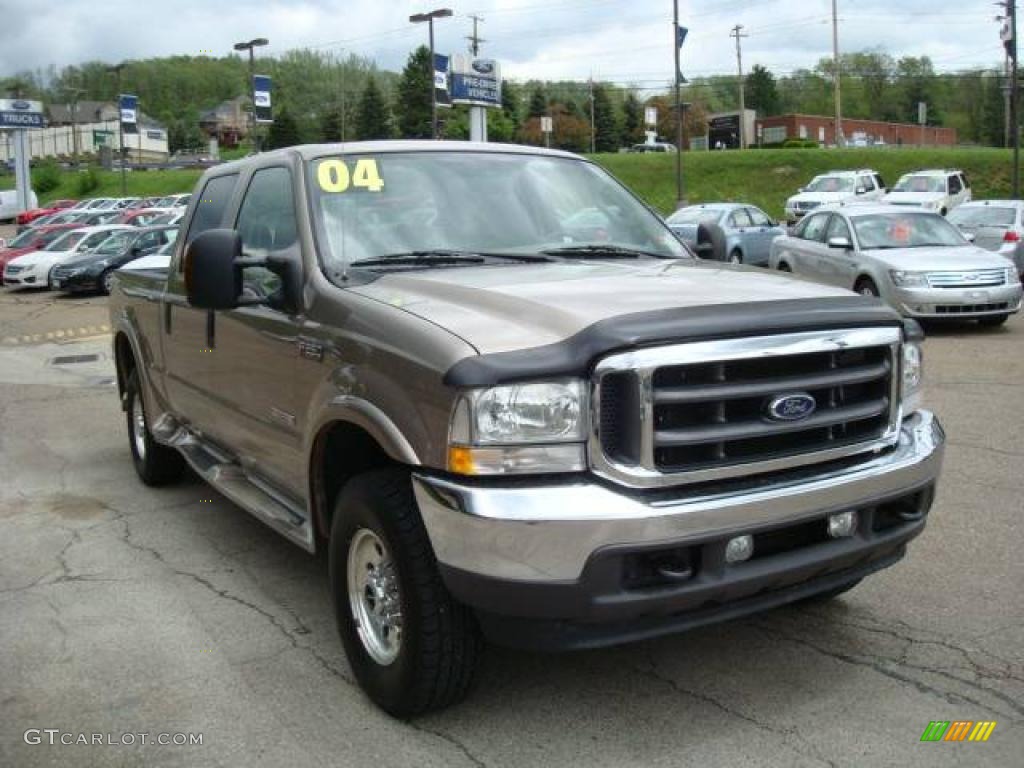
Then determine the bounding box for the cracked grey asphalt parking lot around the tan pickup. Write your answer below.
[0,291,1024,768]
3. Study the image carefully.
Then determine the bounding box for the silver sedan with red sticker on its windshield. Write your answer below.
[770,205,1022,326]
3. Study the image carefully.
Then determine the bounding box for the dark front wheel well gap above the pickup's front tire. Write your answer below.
[309,422,398,539]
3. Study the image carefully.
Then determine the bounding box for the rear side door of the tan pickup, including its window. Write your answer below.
[161,173,239,436]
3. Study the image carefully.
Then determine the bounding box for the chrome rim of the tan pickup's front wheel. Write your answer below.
[347,528,401,667]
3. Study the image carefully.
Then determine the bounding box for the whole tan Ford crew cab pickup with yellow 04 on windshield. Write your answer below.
[110,141,944,716]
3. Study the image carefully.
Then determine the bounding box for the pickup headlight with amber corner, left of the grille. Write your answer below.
[447,380,587,474]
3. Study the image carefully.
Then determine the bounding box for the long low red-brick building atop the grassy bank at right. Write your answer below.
[757,115,956,146]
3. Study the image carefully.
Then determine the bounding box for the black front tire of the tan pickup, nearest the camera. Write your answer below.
[329,469,482,718]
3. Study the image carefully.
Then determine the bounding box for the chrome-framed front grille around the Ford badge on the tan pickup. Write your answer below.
[591,328,900,486]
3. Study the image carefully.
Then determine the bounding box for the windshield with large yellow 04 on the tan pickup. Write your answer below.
[309,152,688,271]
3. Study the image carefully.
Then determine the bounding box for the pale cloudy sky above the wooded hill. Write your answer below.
[0,0,1001,87]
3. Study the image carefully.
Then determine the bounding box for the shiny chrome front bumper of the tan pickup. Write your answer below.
[413,411,945,584]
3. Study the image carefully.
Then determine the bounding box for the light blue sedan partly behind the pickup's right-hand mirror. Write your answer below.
[667,203,785,266]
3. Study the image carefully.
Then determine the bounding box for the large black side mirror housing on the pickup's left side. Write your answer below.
[184,229,242,309]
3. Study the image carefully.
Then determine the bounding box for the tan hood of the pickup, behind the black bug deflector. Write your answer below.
[349,260,851,354]
